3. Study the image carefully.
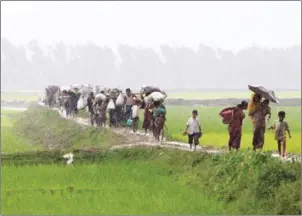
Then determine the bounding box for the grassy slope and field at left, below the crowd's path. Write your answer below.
[1,105,122,152]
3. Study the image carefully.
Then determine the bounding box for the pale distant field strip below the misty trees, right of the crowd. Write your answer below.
[168,90,301,100]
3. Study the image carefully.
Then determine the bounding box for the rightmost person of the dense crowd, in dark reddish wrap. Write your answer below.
[152,101,166,141]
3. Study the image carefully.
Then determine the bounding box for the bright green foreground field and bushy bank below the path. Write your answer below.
[1,148,301,215]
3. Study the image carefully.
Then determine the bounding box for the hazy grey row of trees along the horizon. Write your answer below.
[1,38,301,90]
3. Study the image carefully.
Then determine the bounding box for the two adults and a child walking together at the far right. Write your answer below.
[219,93,291,157]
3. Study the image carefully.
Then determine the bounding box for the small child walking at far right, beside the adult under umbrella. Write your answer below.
[268,111,291,158]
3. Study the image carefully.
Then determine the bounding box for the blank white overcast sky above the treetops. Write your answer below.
[1,1,301,51]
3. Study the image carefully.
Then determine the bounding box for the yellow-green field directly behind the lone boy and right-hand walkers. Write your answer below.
[160,106,301,154]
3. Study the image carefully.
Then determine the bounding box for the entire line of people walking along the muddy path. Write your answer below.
[46,87,291,157]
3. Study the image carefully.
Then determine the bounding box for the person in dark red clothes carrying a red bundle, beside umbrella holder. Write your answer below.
[219,101,248,151]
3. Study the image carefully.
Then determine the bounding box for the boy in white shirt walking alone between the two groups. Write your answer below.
[183,110,202,151]
